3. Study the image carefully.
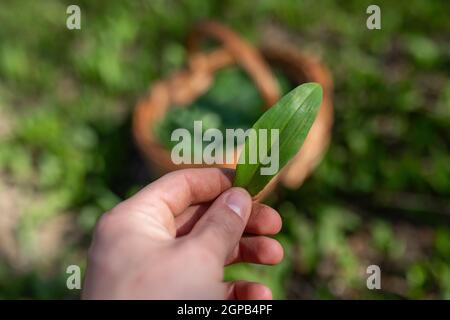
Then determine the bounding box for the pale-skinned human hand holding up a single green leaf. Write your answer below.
[82,168,283,299]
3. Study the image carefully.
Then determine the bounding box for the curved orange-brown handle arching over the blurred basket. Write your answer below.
[187,21,280,108]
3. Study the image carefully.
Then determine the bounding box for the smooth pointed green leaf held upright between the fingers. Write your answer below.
[234,82,322,196]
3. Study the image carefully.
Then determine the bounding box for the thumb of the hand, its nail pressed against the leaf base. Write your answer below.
[190,188,252,263]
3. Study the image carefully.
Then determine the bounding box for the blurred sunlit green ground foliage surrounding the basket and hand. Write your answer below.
[0,0,450,299]
